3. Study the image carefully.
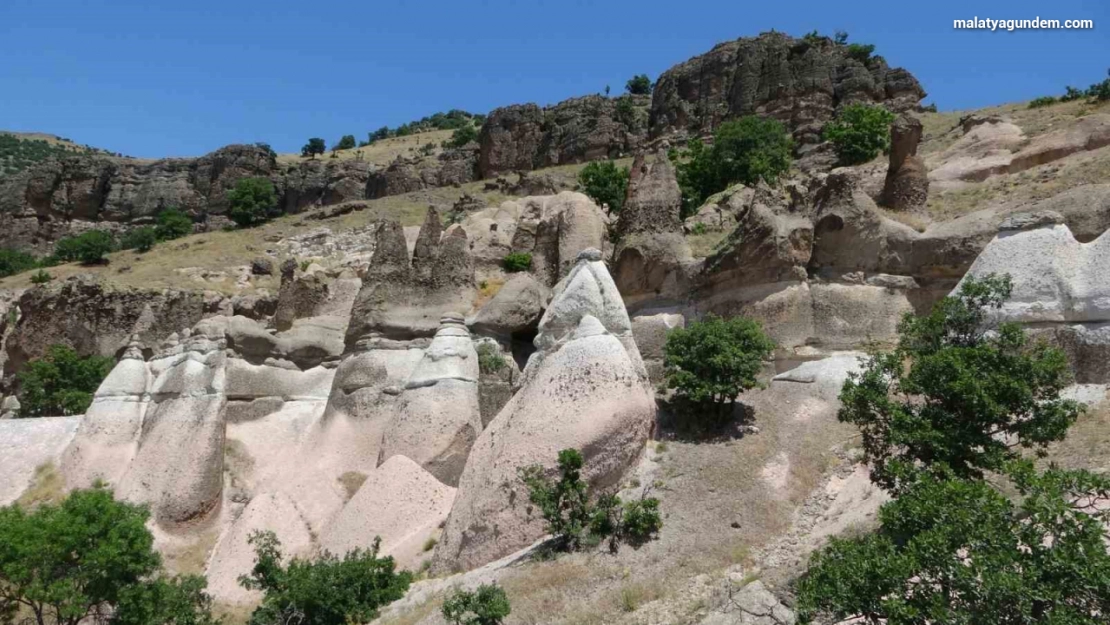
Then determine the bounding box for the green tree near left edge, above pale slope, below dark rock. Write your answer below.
[19,345,114,416]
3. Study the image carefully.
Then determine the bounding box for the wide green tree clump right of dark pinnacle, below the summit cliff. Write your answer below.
[675,115,794,218]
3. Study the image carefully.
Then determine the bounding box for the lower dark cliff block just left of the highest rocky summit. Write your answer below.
[478,95,647,178]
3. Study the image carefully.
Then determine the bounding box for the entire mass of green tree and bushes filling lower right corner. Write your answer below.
[797,275,1110,625]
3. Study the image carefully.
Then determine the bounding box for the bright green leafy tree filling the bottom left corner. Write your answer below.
[0,487,218,625]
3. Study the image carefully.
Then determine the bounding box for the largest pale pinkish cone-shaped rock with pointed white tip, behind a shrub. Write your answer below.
[434,250,655,571]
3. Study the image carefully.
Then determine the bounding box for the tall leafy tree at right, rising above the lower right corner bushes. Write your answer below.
[837,275,1080,490]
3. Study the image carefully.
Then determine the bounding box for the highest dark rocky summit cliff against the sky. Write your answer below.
[650,32,925,151]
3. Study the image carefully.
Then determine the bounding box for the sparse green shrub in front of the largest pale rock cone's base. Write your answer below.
[519,450,663,552]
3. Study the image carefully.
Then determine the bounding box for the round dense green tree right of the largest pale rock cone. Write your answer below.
[663,314,775,423]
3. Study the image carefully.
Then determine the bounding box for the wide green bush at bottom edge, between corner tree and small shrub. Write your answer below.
[239,532,412,625]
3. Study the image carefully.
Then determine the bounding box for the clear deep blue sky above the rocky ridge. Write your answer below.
[0,0,1110,157]
